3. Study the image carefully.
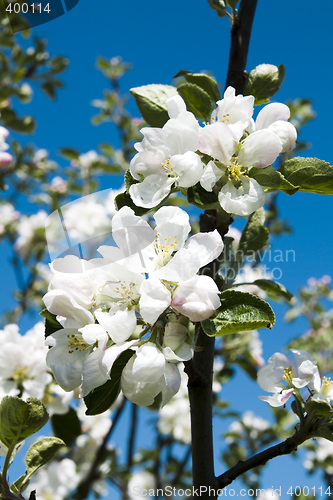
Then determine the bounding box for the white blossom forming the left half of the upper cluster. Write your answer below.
[129,95,203,208]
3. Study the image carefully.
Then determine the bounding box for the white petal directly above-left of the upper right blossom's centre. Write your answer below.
[199,122,238,165]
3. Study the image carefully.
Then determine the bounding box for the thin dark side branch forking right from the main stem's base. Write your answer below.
[217,431,309,488]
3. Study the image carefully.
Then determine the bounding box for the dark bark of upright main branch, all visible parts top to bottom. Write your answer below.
[185,0,257,500]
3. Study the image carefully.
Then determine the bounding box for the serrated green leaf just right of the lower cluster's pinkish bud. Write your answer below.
[201,290,275,337]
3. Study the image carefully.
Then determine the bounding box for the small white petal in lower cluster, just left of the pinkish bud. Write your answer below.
[139,277,171,324]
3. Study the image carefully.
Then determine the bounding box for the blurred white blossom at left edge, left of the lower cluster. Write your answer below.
[0,321,52,399]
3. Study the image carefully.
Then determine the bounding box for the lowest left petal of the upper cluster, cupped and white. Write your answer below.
[129,174,175,208]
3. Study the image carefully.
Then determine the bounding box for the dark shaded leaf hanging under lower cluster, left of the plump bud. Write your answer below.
[84,349,134,415]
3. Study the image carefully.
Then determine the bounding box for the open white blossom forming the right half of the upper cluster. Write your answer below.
[199,87,297,215]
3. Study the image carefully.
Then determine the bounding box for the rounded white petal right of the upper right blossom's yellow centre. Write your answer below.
[238,129,282,168]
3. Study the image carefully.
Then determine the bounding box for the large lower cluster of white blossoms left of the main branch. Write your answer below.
[43,207,223,406]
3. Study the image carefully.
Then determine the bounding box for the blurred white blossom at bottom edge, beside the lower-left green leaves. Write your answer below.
[28,458,81,500]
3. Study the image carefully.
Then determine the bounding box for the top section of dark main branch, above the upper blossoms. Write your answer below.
[226,0,258,94]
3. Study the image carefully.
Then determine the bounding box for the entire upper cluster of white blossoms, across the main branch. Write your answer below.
[129,87,297,216]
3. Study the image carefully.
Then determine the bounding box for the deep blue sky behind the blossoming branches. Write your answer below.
[2,0,333,496]
